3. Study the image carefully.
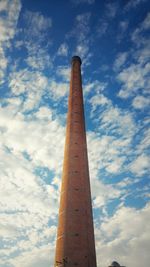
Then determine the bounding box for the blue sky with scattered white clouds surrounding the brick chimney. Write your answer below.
[0,0,150,267]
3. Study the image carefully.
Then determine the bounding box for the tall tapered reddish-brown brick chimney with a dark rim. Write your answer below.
[55,56,96,267]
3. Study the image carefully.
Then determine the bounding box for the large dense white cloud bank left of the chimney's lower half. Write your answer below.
[0,100,64,266]
